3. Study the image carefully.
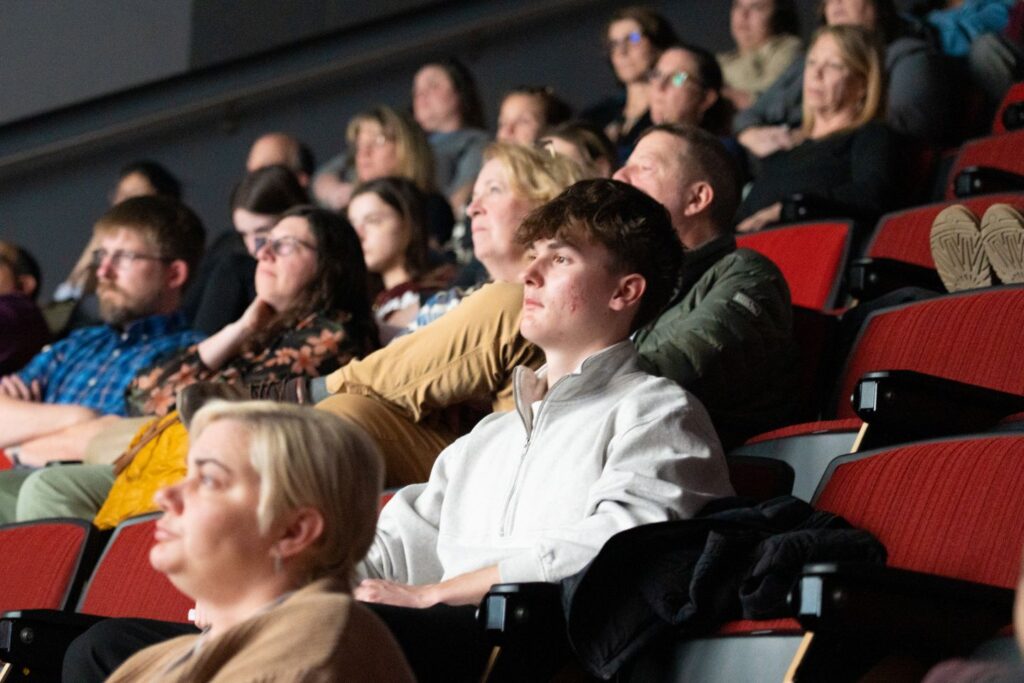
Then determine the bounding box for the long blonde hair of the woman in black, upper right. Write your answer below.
[803,25,886,134]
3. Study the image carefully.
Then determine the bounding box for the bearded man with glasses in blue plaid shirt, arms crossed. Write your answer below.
[0,197,205,523]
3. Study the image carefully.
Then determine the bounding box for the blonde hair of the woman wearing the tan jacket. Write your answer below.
[483,142,587,206]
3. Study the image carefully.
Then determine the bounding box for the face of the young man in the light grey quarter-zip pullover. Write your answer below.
[520,235,633,352]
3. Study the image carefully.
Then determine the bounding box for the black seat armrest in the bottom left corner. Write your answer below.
[0,609,106,681]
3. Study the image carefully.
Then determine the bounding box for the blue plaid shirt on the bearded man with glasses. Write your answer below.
[17,313,203,415]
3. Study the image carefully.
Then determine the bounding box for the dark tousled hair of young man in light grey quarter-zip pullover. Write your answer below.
[516,178,683,330]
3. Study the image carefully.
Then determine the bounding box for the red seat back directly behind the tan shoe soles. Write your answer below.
[866,193,1024,270]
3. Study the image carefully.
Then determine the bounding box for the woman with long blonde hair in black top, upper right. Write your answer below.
[736,25,899,243]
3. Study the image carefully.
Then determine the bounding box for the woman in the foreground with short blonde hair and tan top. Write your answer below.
[101,401,413,681]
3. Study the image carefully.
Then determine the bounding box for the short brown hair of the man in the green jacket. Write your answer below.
[637,124,740,231]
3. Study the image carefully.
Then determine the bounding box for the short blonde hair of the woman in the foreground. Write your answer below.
[188,400,384,585]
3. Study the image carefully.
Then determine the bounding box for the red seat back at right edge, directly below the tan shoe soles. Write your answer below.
[837,287,1024,418]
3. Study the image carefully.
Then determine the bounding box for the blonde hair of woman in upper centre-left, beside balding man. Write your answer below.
[345,104,436,193]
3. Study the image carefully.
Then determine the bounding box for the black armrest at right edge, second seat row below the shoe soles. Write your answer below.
[851,370,1024,447]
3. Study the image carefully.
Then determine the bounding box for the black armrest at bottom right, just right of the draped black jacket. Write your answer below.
[790,563,1014,656]
